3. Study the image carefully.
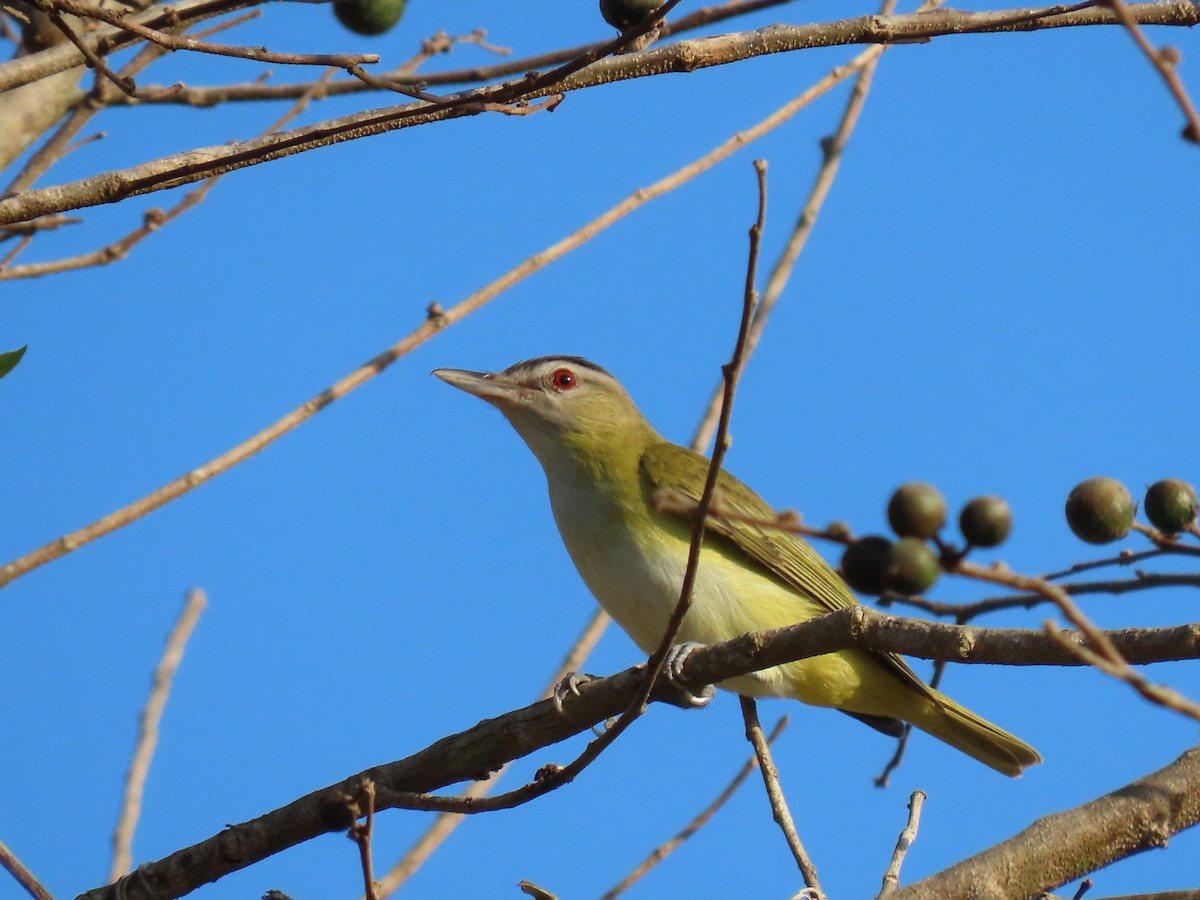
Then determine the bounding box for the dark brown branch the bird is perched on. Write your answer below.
[72,619,1200,900]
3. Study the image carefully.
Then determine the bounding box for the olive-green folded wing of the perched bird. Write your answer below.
[641,442,929,694]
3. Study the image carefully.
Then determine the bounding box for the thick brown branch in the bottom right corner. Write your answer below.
[889,748,1200,900]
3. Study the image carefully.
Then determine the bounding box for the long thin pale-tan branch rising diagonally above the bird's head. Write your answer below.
[0,48,880,588]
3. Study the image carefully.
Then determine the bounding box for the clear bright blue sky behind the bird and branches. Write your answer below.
[0,0,1200,900]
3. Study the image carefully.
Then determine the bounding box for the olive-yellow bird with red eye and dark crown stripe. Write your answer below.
[433,356,1042,776]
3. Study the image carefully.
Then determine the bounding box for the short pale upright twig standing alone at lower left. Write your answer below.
[108,589,206,883]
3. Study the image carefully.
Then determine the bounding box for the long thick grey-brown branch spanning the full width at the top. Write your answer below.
[0,0,1200,224]
